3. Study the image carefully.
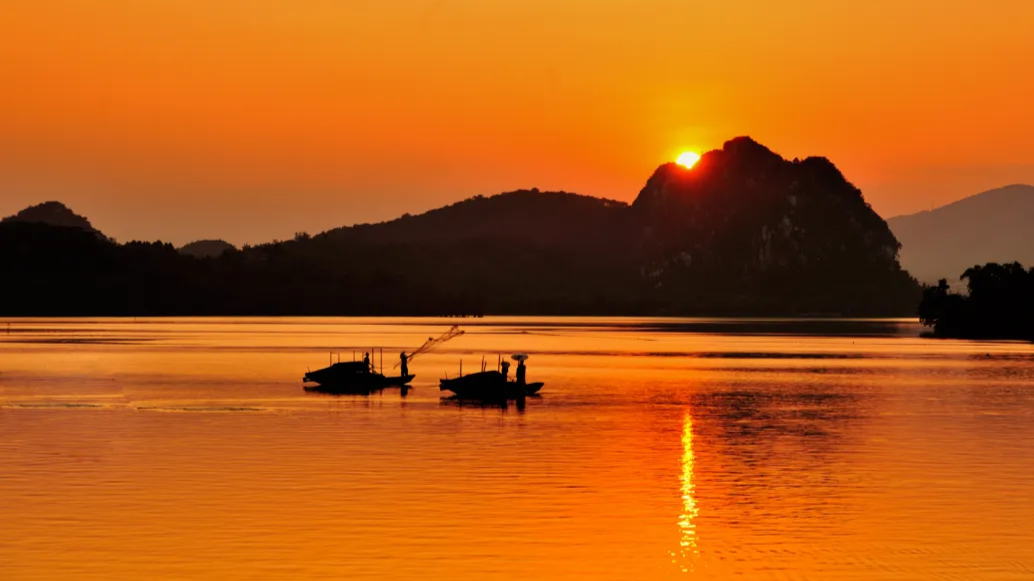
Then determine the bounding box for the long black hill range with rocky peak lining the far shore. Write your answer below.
[0,137,919,315]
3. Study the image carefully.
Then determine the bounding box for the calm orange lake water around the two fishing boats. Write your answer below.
[0,318,1034,580]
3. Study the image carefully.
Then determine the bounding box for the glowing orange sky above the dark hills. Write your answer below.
[0,0,1034,243]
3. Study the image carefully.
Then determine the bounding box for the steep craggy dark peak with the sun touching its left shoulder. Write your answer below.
[633,137,915,312]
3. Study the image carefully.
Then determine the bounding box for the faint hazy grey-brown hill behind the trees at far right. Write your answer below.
[887,185,1034,283]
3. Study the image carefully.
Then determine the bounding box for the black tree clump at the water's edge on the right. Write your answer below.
[919,263,1034,340]
